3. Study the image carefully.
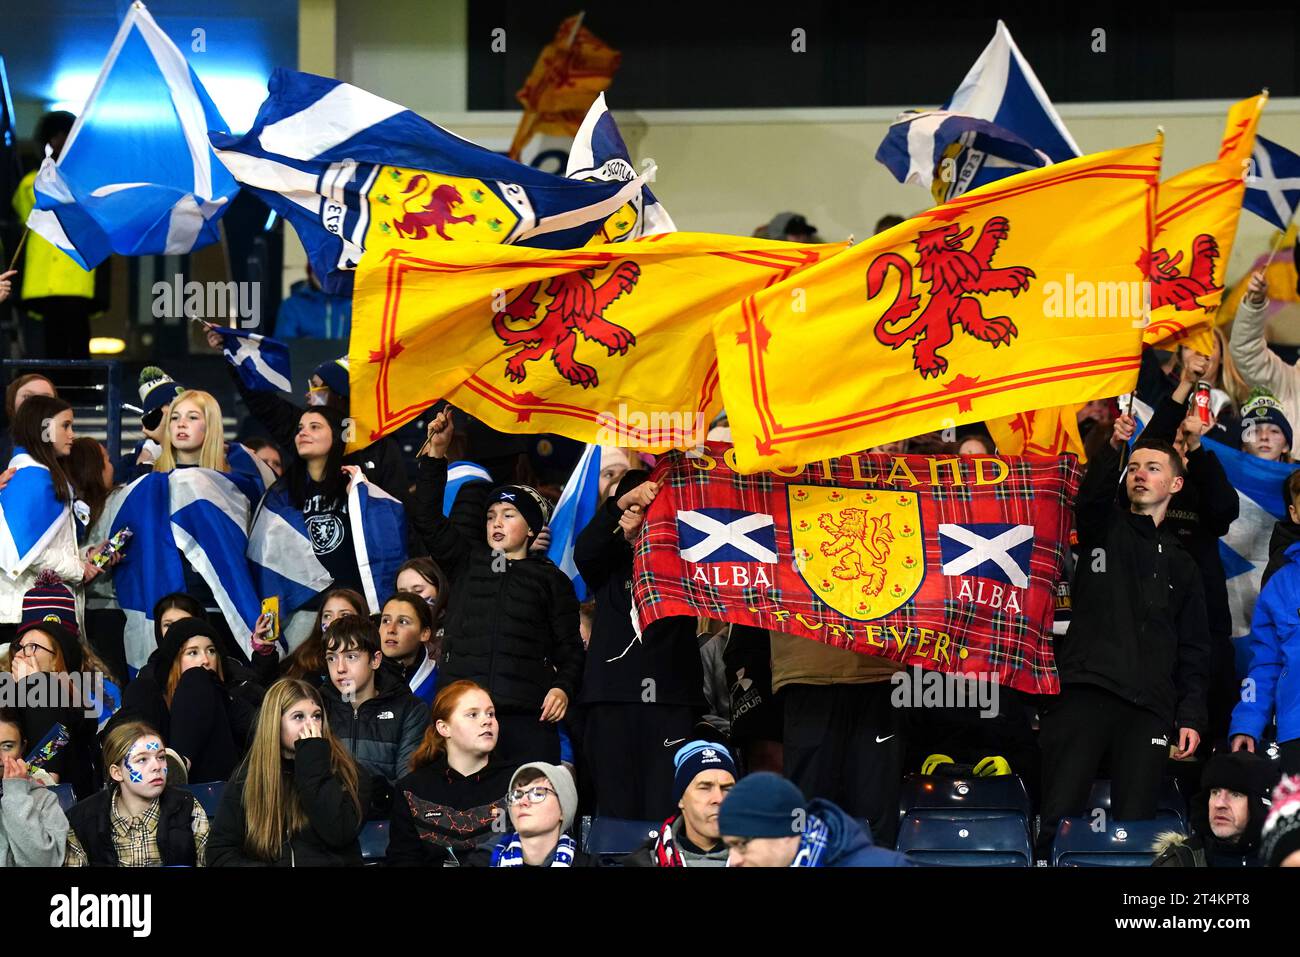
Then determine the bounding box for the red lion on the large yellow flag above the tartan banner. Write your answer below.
[867,216,1035,378]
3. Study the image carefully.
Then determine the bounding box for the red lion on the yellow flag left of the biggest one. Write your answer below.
[491,260,641,389]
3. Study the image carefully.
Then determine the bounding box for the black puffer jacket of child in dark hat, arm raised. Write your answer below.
[411,456,584,713]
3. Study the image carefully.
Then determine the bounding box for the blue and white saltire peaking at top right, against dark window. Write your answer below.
[943,21,1082,163]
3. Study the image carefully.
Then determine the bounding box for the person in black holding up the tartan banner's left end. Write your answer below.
[573,469,705,820]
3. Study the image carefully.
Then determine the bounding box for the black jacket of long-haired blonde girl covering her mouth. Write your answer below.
[208,737,371,867]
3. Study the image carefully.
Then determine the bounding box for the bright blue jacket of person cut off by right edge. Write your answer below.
[1229,542,1300,741]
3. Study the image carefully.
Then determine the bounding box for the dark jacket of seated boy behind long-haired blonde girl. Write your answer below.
[321,668,429,807]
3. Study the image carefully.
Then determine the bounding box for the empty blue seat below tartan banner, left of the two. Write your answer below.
[898,811,1034,867]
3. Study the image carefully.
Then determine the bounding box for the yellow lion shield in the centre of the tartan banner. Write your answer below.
[787,485,926,622]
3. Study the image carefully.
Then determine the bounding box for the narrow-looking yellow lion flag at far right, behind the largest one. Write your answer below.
[1139,94,1269,355]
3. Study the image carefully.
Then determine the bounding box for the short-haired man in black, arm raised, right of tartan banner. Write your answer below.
[1039,416,1209,850]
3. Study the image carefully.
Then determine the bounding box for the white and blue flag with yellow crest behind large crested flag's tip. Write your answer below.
[564,94,677,246]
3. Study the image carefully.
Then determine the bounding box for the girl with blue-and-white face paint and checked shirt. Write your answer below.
[64,722,208,867]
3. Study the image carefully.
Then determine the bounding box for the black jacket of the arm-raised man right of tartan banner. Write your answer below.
[1057,442,1210,736]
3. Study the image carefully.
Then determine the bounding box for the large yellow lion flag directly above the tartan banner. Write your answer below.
[714,142,1161,472]
